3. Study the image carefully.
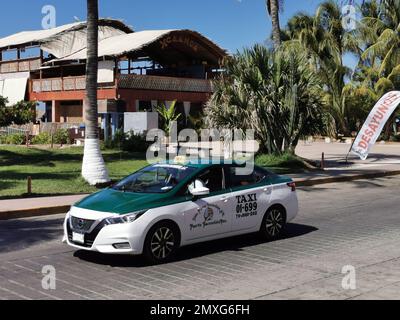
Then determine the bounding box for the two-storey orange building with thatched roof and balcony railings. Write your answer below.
[0,19,226,137]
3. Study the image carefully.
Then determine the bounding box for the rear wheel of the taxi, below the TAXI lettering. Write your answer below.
[260,206,286,239]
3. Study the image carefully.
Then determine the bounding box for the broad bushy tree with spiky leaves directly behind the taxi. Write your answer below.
[205,45,329,154]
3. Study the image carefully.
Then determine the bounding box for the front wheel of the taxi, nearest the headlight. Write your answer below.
[144,222,179,264]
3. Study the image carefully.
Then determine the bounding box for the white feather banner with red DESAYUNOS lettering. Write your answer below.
[351,91,400,160]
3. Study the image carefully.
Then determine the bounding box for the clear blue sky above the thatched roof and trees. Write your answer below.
[0,0,358,64]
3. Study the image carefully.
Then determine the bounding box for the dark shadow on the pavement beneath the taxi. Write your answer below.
[74,223,318,268]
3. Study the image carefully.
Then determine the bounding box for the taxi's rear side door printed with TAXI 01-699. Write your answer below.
[225,166,272,232]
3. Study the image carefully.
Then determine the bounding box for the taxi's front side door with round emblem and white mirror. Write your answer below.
[183,166,233,241]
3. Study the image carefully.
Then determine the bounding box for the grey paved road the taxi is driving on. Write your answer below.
[0,176,400,299]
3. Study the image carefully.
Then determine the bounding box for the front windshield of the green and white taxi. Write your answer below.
[113,165,195,193]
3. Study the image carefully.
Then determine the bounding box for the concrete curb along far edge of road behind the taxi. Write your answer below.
[0,170,400,221]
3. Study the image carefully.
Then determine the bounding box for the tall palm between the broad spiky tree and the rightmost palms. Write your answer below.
[284,0,361,133]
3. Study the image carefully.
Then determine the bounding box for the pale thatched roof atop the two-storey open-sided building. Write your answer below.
[0,19,227,65]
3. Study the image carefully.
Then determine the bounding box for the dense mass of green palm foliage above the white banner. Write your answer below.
[276,0,400,134]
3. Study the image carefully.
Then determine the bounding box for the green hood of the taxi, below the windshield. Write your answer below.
[75,189,173,214]
